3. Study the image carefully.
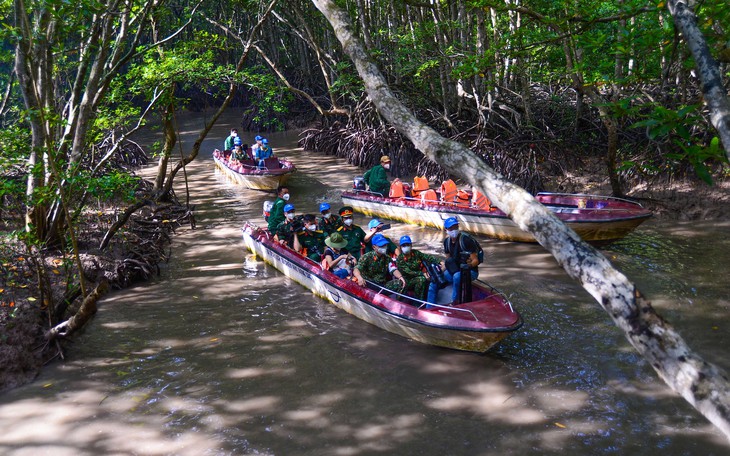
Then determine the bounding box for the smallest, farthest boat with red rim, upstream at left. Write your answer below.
[213,149,297,190]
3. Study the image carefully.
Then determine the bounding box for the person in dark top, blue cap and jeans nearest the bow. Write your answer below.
[427,217,483,305]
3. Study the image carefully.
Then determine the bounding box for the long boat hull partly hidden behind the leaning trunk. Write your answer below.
[342,189,652,242]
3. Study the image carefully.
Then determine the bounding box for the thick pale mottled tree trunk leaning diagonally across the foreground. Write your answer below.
[312,0,730,438]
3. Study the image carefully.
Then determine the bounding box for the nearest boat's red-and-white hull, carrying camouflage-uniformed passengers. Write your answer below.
[242,223,522,352]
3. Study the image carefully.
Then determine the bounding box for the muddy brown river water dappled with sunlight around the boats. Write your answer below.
[0,112,730,456]
